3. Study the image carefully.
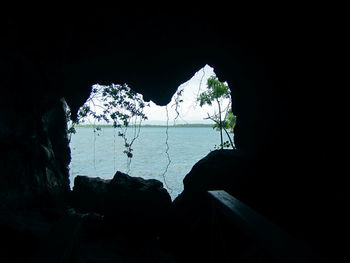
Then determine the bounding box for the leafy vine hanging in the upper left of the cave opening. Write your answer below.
[67,84,148,171]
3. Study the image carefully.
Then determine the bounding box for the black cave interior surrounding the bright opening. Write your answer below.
[0,5,350,262]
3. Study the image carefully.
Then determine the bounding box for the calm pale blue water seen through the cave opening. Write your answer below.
[70,127,232,199]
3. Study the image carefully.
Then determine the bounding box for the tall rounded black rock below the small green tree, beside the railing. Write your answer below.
[169,150,262,262]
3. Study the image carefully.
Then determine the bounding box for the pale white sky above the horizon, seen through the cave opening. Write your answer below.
[80,65,230,125]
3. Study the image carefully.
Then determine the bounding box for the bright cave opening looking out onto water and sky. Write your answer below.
[68,65,236,199]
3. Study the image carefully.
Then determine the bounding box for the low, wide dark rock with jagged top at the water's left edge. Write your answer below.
[71,172,171,228]
